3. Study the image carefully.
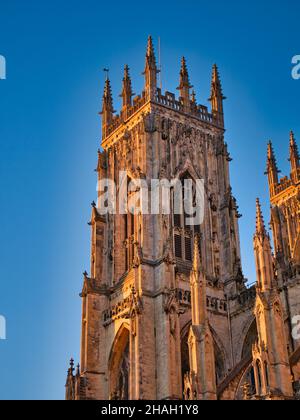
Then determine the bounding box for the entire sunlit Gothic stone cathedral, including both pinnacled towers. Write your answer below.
[66,38,300,400]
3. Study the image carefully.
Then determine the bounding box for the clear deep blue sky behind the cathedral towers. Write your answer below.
[0,0,300,399]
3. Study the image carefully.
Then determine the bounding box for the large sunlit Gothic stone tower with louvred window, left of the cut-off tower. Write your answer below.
[67,37,251,400]
